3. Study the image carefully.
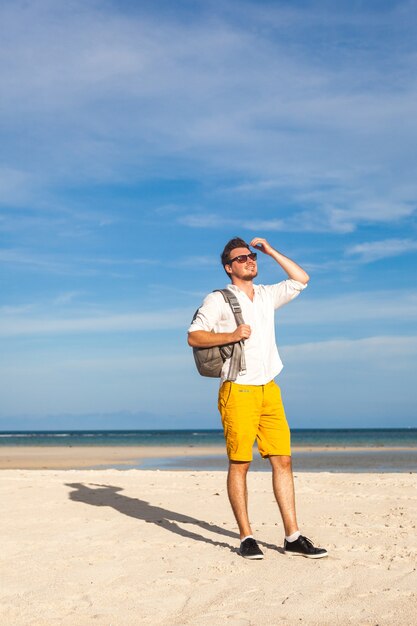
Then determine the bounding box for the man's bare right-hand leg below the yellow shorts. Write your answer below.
[269,455,298,537]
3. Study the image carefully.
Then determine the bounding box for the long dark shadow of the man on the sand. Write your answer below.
[65,483,277,552]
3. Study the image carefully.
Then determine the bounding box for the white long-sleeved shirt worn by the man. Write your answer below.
[188,279,307,385]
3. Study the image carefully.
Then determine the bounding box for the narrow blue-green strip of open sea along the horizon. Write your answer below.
[0,428,417,448]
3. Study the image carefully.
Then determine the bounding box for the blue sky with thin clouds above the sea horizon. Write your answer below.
[0,0,417,429]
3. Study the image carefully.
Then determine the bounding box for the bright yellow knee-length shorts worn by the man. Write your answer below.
[218,380,291,461]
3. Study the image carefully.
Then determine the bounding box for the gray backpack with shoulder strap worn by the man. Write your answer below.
[193,289,246,381]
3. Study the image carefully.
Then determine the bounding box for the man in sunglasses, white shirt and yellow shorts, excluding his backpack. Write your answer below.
[188,237,327,559]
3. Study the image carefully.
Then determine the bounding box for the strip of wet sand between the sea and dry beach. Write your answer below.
[0,446,417,471]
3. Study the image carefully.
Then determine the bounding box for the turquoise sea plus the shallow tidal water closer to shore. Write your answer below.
[0,428,417,472]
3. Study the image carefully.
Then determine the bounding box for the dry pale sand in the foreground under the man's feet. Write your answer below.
[0,470,417,626]
